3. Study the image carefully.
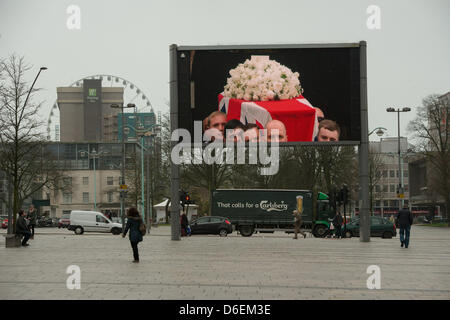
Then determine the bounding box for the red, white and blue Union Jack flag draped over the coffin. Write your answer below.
[219,94,318,141]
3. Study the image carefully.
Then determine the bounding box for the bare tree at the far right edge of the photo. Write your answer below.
[408,93,450,223]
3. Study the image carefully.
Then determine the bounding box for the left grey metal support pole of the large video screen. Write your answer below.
[169,44,180,240]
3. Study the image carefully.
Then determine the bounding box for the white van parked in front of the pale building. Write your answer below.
[67,210,122,234]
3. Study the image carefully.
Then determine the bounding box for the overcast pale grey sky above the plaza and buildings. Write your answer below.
[0,0,450,140]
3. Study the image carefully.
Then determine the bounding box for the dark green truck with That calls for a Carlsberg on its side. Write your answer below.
[211,189,335,237]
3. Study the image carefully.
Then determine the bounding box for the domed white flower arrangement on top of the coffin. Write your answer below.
[223,56,303,101]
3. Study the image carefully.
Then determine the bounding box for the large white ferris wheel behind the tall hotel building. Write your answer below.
[47,74,155,141]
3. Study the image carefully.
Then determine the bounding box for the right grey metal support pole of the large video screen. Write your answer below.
[358,41,370,242]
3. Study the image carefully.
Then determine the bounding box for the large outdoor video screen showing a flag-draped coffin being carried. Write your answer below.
[176,43,361,143]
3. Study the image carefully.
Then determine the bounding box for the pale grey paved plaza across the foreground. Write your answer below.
[0,226,450,300]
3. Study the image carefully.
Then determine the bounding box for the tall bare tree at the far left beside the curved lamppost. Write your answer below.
[0,54,67,228]
